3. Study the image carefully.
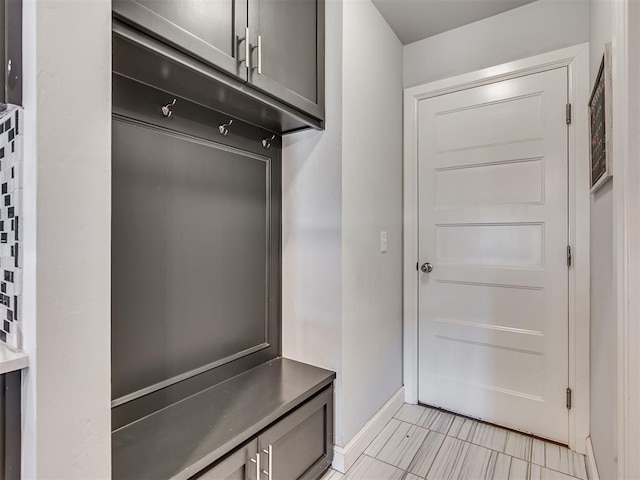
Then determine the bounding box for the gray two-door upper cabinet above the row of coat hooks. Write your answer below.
[113,0,324,125]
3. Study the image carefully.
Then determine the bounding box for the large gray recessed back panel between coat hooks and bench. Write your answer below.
[112,121,269,397]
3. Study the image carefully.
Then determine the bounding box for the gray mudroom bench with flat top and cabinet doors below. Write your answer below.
[112,358,335,480]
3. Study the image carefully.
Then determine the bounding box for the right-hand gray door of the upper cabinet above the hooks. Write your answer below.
[249,0,324,119]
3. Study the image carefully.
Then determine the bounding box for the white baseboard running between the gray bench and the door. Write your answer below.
[331,387,404,473]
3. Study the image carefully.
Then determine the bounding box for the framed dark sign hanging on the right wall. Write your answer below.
[589,43,613,193]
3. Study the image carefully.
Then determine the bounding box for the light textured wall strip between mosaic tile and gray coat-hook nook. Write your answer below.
[23,0,111,480]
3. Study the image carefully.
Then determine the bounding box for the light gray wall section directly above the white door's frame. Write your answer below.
[404,0,589,87]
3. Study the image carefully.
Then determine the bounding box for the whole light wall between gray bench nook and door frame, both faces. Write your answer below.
[282,0,402,446]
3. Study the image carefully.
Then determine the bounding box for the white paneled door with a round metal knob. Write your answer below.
[418,68,569,443]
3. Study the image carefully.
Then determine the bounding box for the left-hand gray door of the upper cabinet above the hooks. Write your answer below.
[113,0,247,80]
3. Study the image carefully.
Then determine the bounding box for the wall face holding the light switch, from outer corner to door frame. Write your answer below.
[342,0,402,441]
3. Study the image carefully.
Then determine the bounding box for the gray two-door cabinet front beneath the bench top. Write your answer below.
[192,386,333,480]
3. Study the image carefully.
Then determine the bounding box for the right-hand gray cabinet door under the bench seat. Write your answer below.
[258,387,333,480]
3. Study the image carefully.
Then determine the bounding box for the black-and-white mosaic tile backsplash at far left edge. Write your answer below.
[0,106,23,349]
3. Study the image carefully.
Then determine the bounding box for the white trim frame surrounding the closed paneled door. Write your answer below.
[403,43,590,453]
